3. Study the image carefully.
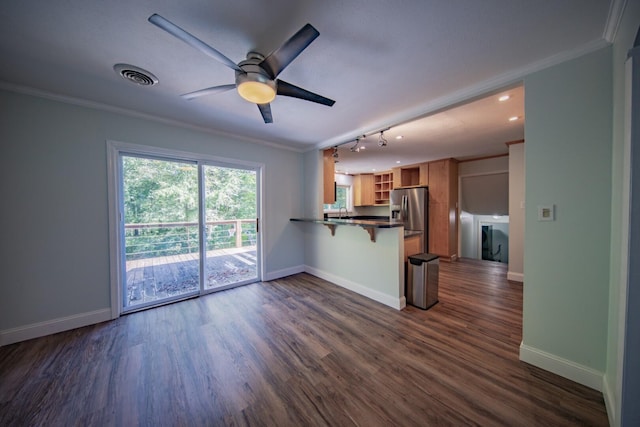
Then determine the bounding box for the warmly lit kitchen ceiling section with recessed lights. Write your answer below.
[336,85,525,174]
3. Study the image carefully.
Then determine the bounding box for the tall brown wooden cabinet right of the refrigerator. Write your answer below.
[429,159,458,261]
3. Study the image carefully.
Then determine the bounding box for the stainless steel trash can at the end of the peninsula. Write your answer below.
[406,253,440,310]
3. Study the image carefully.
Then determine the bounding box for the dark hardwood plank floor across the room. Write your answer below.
[0,259,608,426]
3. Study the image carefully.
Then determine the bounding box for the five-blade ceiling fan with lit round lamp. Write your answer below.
[149,13,335,123]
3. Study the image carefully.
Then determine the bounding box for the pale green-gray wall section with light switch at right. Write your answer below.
[521,47,612,372]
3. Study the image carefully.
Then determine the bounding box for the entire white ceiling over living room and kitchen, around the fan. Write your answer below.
[0,0,623,170]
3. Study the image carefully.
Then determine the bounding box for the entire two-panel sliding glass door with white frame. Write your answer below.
[109,143,261,317]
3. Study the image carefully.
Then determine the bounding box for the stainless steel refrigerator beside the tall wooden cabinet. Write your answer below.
[389,187,429,253]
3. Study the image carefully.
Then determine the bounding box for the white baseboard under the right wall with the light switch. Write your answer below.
[520,343,604,392]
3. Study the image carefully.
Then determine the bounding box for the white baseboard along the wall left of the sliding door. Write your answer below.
[0,308,111,347]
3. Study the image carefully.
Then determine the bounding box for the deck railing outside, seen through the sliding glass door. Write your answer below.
[124,219,256,261]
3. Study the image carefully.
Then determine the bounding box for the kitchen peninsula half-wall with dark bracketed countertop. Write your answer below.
[290,218,406,310]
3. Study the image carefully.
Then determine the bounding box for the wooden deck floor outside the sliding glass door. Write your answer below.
[126,246,257,306]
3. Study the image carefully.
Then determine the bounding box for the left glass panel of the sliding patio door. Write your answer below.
[122,156,200,311]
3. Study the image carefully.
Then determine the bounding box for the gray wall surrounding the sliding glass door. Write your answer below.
[0,91,304,333]
